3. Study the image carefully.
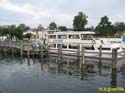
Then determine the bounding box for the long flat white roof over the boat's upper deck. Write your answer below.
[51,31,95,35]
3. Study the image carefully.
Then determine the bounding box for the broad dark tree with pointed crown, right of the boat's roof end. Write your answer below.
[95,16,114,36]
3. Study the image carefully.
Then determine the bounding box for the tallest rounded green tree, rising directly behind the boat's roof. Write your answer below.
[73,12,88,31]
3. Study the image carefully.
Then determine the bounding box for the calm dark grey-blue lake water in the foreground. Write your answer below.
[0,57,125,93]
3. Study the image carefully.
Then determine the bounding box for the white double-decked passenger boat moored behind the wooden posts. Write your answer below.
[48,31,123,57]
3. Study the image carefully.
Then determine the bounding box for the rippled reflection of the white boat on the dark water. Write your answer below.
[34,57,111,78]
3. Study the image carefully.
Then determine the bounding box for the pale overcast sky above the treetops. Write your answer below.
[0,0,125,27]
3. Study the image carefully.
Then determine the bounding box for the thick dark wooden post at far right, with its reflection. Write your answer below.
[111,49,117,87]
